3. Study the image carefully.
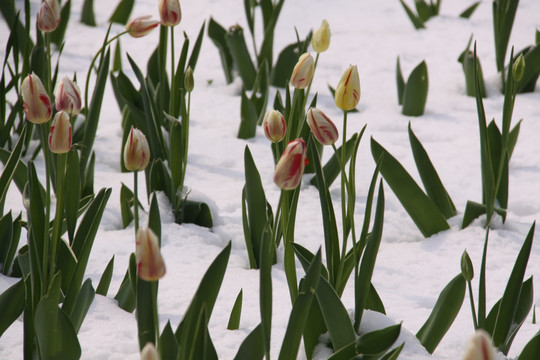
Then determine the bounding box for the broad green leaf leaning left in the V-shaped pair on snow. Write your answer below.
[371,138,450,237]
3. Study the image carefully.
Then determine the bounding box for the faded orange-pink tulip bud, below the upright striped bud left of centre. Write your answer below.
[135,228,165,281]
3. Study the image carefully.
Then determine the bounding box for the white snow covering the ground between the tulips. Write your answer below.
[0,0,540,360]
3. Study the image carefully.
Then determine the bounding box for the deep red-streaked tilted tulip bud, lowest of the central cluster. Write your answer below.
[274,139,307,190]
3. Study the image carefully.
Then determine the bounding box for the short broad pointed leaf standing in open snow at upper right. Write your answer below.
[401,61,429,116]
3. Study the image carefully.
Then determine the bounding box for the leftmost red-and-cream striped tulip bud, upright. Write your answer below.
[21,73,52,124]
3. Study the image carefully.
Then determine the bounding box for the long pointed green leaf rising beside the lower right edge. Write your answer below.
[492,223,535,347]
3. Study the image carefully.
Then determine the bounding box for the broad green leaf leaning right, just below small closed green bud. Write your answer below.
[416,273,465,354]
